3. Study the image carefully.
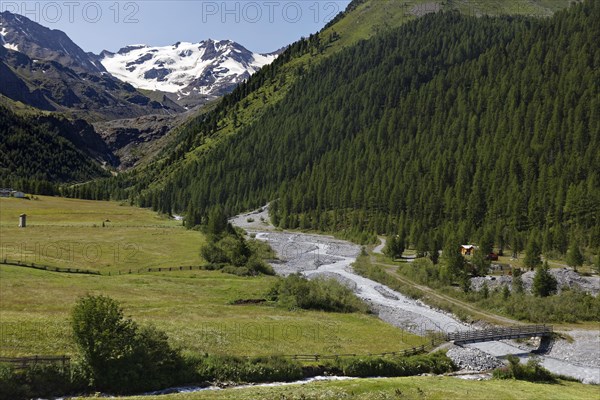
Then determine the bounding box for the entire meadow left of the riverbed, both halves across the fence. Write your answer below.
[0,197,422,357]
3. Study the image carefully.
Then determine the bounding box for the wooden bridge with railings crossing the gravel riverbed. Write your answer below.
[447,325,553,344]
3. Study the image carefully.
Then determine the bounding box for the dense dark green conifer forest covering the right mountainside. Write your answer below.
[65,1,600,251]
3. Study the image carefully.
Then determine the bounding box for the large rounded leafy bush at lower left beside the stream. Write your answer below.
[72,296,191,393]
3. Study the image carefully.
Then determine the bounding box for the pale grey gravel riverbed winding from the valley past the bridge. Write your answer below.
[231,206,600,384]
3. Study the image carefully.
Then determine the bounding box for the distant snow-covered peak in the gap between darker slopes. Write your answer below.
[99,39,276,99]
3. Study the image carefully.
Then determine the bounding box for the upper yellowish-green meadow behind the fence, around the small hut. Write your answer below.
[0,196,203,273]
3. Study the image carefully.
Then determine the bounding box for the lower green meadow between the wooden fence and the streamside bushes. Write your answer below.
[0,265,423,356]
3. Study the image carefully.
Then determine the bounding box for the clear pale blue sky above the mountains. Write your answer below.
[0,0,350,53]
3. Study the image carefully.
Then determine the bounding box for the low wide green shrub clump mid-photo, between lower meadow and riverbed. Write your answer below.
[267,274,368,313]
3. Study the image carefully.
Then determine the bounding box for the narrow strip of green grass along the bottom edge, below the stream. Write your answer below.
[90,377,600,400]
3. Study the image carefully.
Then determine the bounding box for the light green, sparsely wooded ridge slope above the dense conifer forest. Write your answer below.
[102,0,571,180]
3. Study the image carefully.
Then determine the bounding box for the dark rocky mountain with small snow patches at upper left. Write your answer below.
[0,11,183,120]
